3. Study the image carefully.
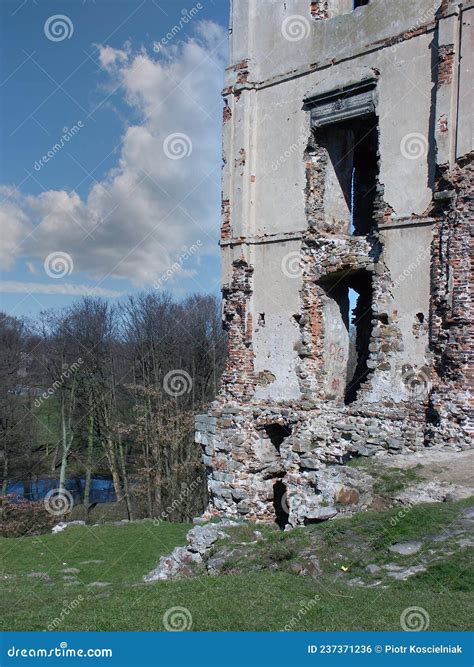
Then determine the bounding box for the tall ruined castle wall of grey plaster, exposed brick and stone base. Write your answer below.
[197,0,474,525]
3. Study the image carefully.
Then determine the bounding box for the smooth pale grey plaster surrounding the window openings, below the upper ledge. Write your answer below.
[225,35,433,398]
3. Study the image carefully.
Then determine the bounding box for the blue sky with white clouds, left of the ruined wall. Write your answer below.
[0,0,229,315]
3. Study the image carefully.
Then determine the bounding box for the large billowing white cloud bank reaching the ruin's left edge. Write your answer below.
[0,21,226,285]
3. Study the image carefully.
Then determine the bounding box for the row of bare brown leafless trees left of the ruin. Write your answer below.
[0,292,226,520]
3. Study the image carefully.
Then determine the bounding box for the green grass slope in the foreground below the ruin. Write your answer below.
[0,503,472,631]
